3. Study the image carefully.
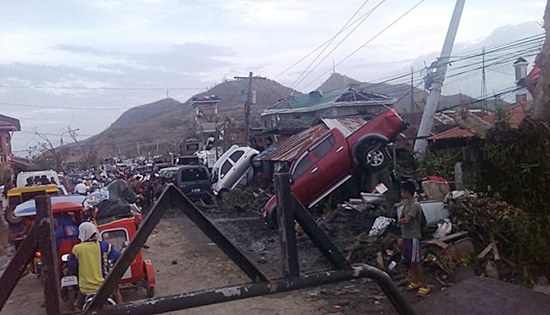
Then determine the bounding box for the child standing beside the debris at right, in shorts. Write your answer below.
[397,181,430,297]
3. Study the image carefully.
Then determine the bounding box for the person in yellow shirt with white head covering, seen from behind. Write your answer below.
[69,222,122,306]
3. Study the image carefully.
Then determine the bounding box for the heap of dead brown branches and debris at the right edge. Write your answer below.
[448,195,548,282]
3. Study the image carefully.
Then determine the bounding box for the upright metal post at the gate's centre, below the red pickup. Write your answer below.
[274,173,300,278]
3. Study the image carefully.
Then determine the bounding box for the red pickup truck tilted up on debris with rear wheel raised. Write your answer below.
[264,108,405,226]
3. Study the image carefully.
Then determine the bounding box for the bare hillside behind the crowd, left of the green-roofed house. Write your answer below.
[74,78,293,160]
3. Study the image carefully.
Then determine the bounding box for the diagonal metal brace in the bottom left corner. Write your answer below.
[0,224,37,310]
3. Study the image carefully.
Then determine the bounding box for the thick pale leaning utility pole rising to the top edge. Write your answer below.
[414,0,466,160]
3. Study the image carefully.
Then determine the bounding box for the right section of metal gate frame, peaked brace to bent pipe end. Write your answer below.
[84,173,415,315]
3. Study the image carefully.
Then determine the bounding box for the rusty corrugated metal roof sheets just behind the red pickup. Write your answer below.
[258,117,366,162]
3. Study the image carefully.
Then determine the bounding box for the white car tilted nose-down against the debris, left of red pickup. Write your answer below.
[212,145,260,196]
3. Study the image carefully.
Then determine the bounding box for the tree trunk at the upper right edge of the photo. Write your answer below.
[528,0,550,122]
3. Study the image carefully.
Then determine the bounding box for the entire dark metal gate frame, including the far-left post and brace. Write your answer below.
[0,177,415,315]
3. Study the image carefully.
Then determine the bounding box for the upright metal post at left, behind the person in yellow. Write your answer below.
[34,196,61,315]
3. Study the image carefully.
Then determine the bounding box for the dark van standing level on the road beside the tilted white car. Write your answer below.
[159,165,211,200]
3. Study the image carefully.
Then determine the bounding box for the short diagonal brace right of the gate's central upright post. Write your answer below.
[293,195,351,270]
